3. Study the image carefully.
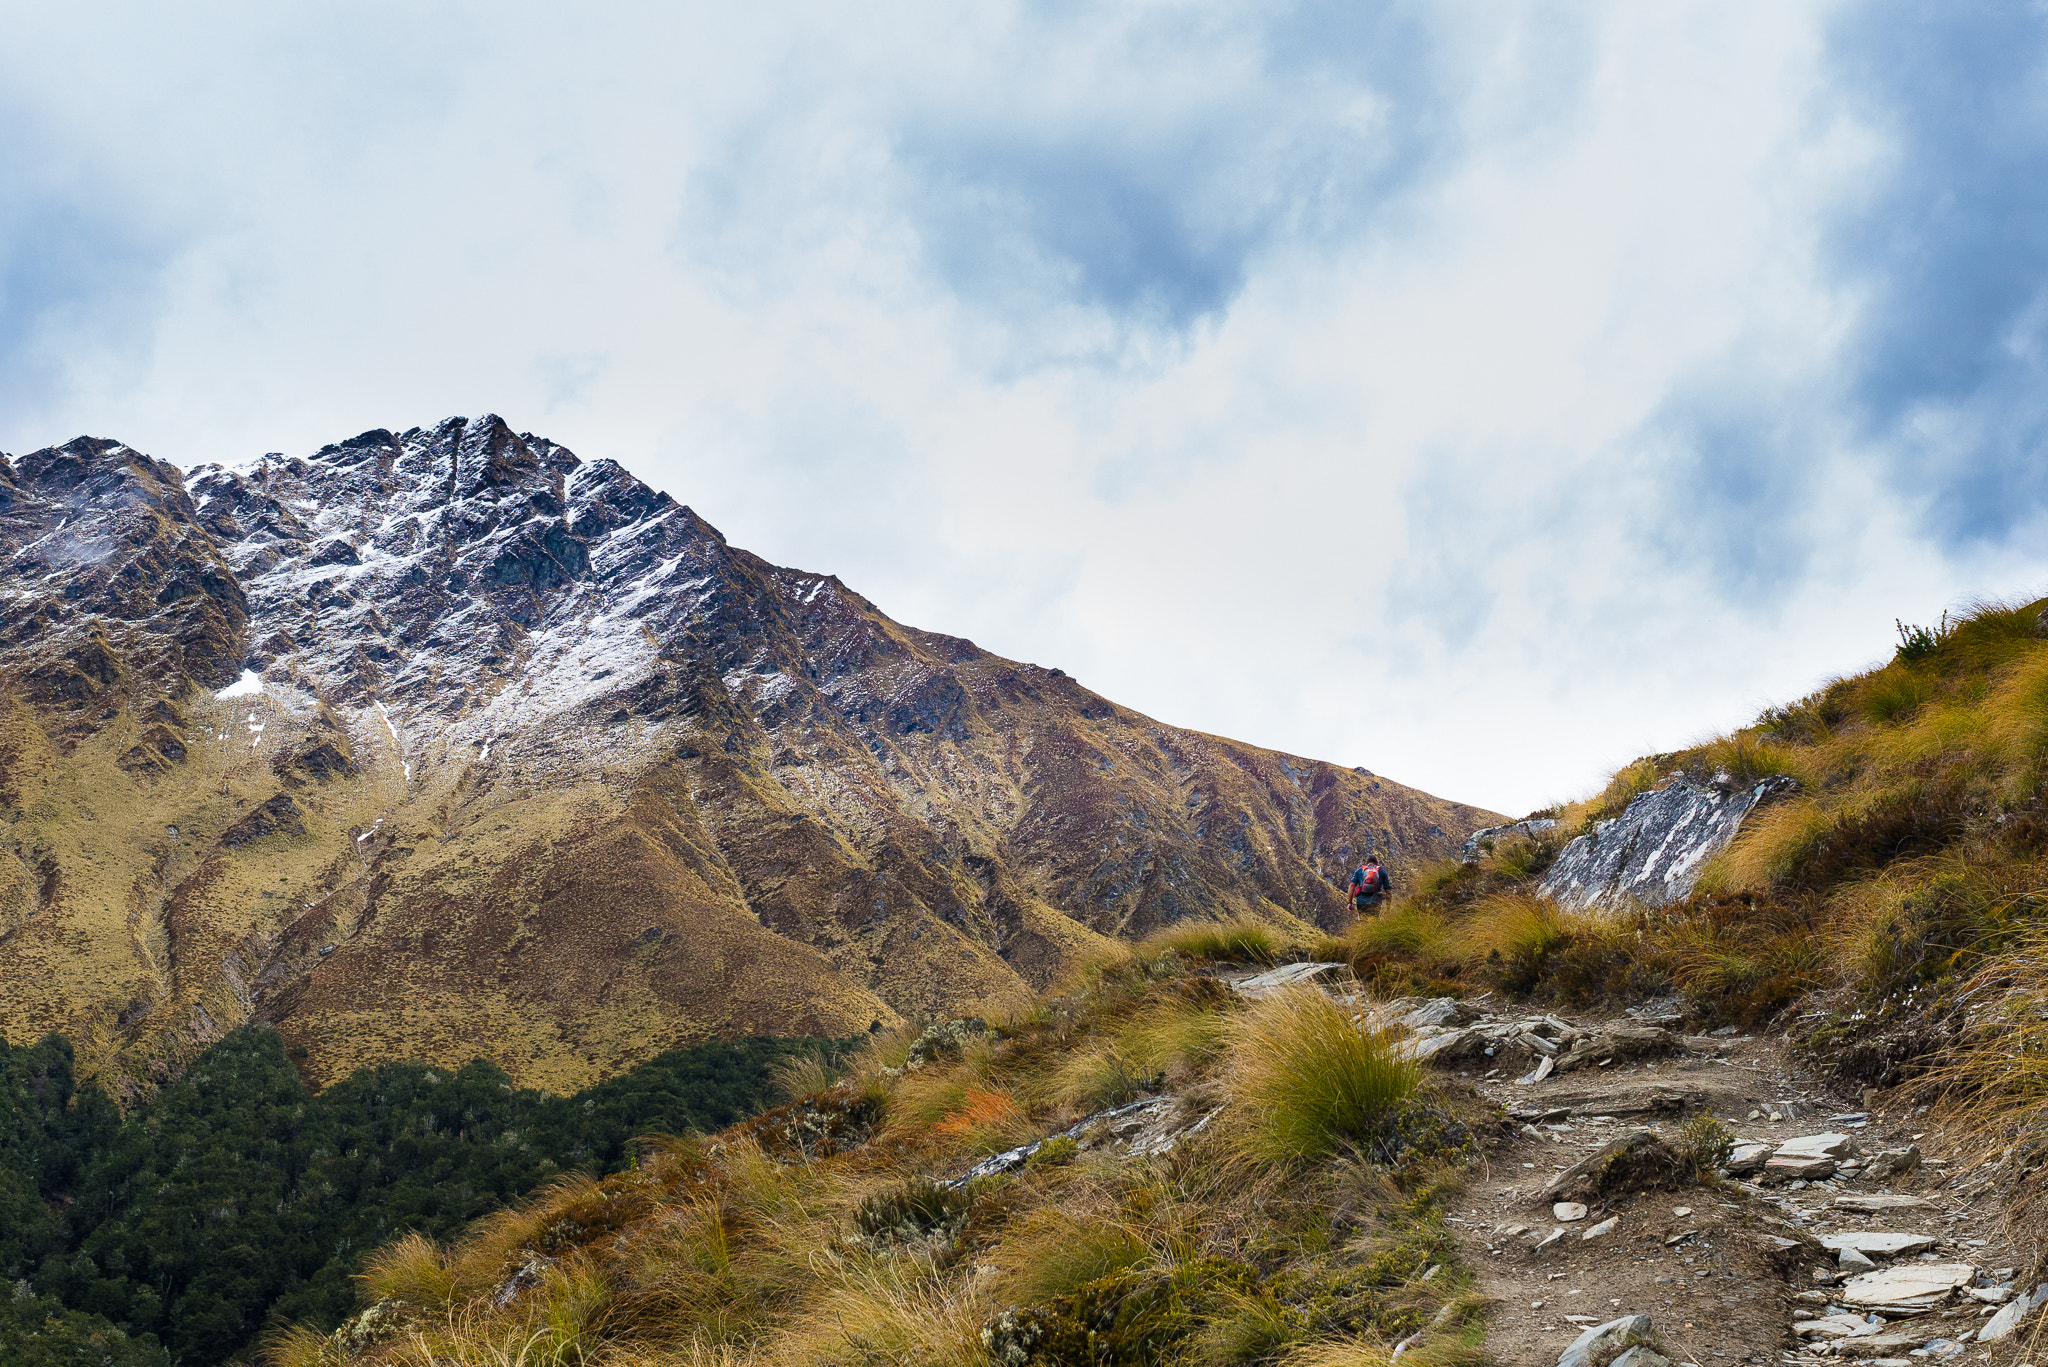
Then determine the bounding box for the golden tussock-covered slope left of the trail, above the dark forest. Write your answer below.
[268,937,1479,1367]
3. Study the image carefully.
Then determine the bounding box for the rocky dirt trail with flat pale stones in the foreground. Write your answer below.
[1380,998,2048,1367]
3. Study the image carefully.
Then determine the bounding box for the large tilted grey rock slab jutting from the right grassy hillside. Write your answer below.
[1540,779,1792,908]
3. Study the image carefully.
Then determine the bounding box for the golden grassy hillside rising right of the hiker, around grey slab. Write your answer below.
[1335,600,2048,1221]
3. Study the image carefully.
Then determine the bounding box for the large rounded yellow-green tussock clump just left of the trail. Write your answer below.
[1227,986,1419,1164]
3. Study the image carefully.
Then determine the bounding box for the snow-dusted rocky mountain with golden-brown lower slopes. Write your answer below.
[0,418,1499,1086]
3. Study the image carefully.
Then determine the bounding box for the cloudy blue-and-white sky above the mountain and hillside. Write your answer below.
[0,0,2048,814]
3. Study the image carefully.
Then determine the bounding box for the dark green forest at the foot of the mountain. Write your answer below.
[0,1027,848,1367]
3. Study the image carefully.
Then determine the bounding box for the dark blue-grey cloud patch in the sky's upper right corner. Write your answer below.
[1829,0,2048,543]
